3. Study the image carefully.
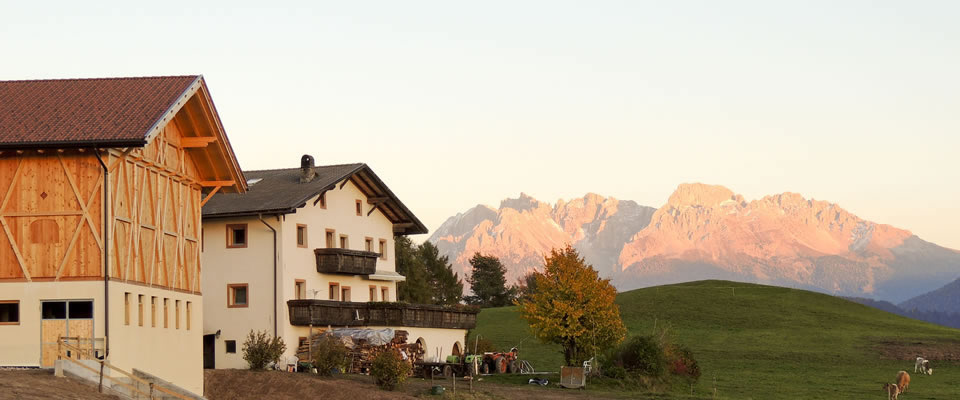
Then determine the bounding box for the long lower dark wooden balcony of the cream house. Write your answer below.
[287,300,479,329]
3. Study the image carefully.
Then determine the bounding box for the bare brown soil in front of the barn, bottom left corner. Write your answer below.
[0,369,117,400]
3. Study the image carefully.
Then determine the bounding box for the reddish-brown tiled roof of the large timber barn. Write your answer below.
[0,76,199,148]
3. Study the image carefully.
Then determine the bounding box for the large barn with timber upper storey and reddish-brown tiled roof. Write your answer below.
[0,76,246,393]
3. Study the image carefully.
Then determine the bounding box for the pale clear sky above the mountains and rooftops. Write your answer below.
[0,0,960,249]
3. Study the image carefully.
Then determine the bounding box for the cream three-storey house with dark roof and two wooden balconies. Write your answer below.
[202,155,476,368]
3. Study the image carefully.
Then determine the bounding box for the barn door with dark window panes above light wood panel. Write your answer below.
[40,300,93,368]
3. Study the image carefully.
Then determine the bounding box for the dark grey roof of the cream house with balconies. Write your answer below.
[203,163,427,234]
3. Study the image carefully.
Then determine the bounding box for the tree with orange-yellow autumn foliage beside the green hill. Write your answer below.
[520,245,626,365]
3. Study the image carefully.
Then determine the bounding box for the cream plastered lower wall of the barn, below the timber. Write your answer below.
[0,280,203,394]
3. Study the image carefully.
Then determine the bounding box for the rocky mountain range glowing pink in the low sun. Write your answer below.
[428,183,960,302]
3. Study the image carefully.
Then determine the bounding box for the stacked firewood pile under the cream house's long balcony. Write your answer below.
[297,330,424,374]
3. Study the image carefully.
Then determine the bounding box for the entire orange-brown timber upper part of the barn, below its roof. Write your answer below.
[0,79,245,294]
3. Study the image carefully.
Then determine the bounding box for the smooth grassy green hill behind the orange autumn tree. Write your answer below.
[468,281,960,399]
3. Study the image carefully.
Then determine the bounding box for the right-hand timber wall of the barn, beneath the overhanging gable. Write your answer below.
[110,118,201,292]
